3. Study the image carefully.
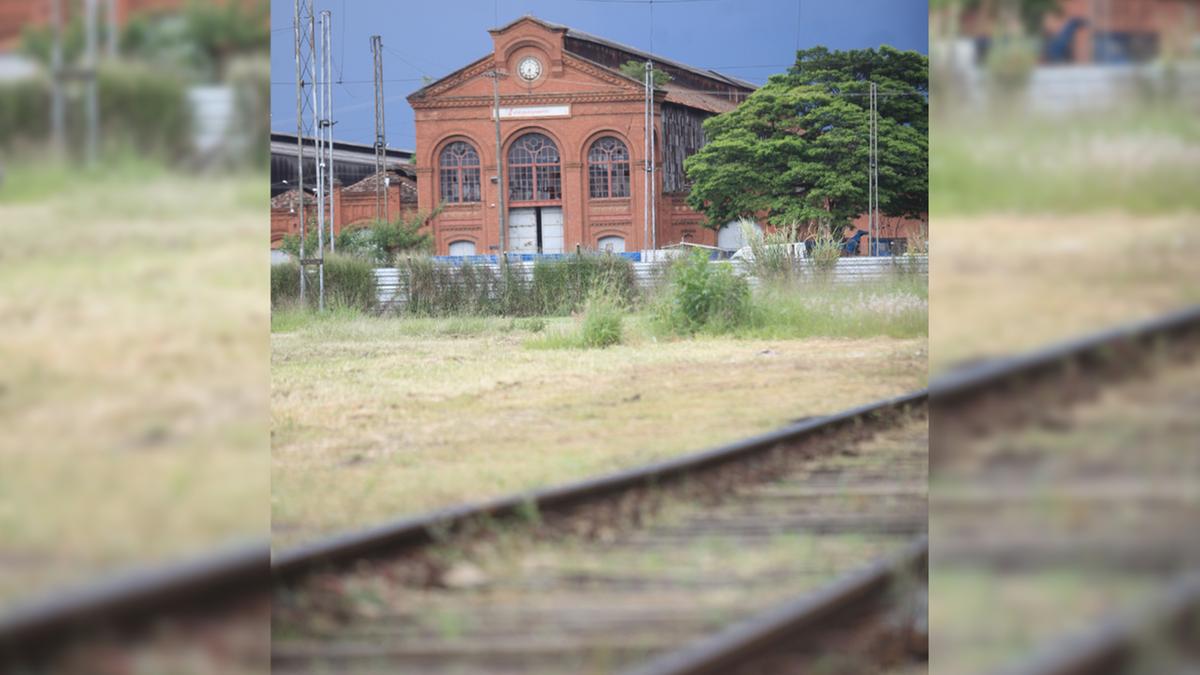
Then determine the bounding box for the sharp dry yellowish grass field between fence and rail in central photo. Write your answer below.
[271,318,926,545]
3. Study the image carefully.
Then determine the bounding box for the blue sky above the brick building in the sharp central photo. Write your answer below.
[271,0,929,149]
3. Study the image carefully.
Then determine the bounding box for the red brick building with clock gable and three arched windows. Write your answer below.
[408,17,755,255]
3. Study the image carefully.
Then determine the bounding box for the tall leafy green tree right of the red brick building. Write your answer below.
[684,47,929,227]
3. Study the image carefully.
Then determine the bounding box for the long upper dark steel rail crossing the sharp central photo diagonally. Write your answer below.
[271,389,928,584]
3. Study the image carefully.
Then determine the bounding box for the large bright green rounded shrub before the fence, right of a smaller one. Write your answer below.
[655,251,751,335]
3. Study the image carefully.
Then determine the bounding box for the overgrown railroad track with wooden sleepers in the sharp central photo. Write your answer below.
[272,393,928,674]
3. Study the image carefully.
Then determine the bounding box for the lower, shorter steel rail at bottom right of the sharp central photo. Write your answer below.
[625,537,929,675]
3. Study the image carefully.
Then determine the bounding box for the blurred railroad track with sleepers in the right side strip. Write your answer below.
[930,307,1200,675]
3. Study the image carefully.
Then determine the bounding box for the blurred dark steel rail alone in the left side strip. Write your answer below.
[0,540,270,658]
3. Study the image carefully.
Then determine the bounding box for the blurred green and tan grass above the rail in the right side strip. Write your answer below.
[930,107,1200,372]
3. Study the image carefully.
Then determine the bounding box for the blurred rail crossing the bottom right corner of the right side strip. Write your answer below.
[1000,572,1200,675]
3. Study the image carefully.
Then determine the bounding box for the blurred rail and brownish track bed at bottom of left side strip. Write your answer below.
[0,540,270,675]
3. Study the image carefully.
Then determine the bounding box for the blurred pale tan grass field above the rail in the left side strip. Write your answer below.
[0,159,270,608]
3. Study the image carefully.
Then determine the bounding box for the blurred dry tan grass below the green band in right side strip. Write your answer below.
[929,214,1200,372]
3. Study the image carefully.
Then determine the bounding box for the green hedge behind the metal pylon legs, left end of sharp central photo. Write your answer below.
[271,255,376,311]
